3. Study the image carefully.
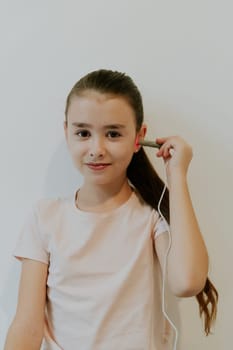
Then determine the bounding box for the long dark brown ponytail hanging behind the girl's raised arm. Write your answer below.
[127,147,218,335]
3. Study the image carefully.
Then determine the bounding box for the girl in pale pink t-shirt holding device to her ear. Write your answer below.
[5,70,218,350]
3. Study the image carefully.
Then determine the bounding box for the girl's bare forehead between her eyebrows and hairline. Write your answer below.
[68,90,135,123]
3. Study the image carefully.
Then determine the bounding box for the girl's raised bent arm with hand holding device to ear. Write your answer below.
[156,137,208,297]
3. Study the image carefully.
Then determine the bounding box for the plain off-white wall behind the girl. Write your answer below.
[0,0,233,350]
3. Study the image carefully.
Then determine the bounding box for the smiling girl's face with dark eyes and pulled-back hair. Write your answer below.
[64,90,145,185]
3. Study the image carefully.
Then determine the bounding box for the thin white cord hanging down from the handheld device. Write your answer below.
[158,164,178,350]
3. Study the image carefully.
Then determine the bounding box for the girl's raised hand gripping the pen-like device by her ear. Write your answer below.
[156,136,193,175]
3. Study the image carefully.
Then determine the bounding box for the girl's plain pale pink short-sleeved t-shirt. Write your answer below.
[14,192,172,350]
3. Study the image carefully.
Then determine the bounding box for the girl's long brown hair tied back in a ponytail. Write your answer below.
[65,69,218,335]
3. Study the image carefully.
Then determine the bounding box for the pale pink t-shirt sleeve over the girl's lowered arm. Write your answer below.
[13,204,49,264]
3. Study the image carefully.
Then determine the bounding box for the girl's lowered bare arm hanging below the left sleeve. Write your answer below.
[4,259,48,350]
